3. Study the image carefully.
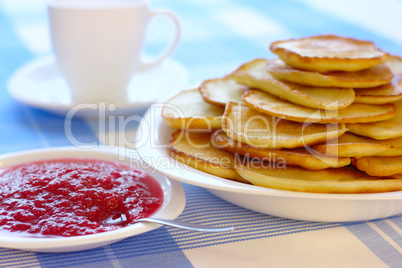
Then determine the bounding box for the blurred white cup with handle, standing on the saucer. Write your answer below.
[48,0,180,103]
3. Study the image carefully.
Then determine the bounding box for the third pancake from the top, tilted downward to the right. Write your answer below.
[231,59,355,110]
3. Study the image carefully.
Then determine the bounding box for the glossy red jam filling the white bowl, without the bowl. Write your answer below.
[0,159,163,236]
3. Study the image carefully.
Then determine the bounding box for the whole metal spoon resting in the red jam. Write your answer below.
[102,214,234,232]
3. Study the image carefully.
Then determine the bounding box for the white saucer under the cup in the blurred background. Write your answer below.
[8,57,188,117]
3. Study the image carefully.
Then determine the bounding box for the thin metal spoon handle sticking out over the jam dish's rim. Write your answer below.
[136,218,234,232]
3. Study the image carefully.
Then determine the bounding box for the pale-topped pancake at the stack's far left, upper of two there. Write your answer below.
[162,89,224,130]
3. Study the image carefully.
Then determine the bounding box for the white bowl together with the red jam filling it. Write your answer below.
[0,147,185,252]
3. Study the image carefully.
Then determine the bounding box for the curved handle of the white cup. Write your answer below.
[139,10,181,71]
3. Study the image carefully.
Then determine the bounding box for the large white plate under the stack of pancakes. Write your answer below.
[136,106,402,222]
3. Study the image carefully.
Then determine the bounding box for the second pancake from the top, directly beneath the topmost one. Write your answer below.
[267,59,393,88]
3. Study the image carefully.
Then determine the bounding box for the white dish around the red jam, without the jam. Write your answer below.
[0,147,186,252]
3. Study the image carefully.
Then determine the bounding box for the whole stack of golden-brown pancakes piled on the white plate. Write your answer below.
[162,35,402,193]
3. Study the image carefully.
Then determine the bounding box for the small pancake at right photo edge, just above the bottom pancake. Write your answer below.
[353,156,402,178]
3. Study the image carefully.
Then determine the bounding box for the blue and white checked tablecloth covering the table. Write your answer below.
[0,0,402,267]
